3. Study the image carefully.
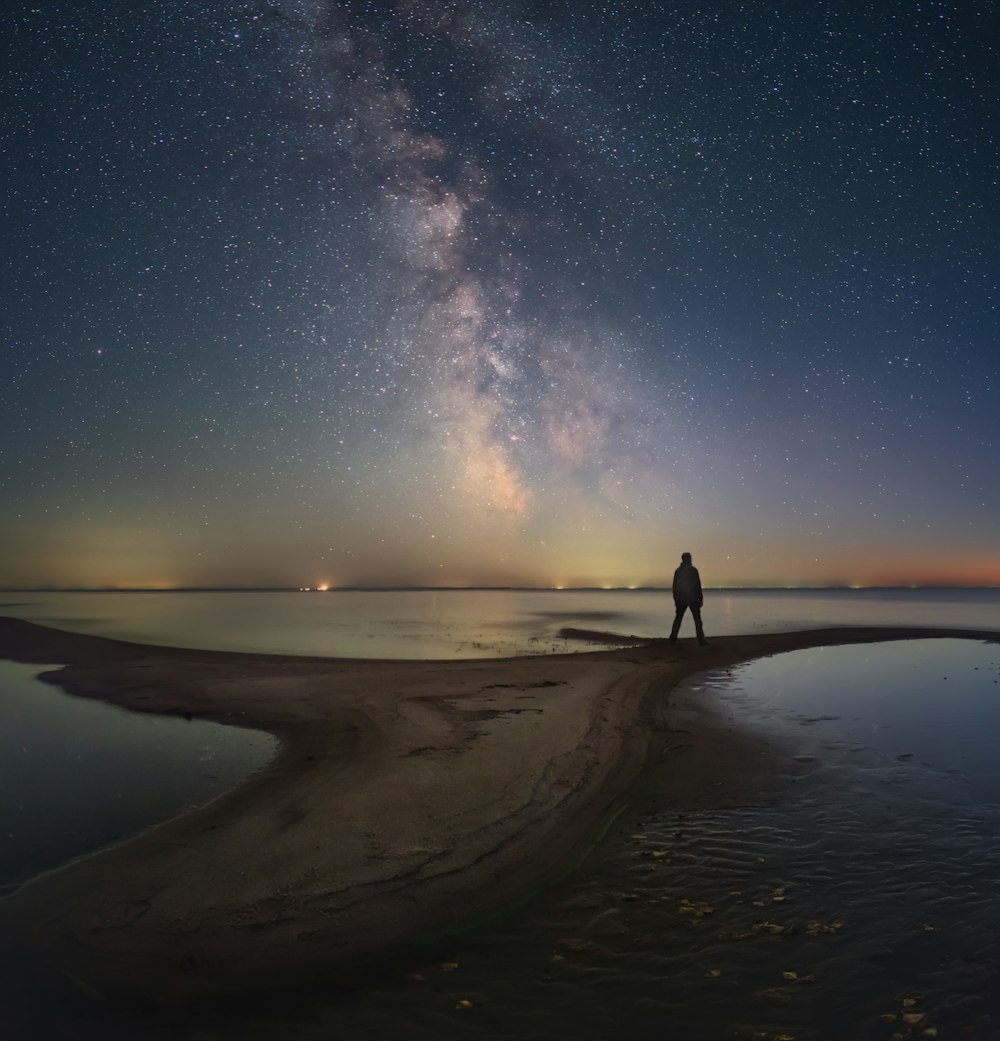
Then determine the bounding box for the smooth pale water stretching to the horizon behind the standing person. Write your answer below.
[0,589,1000,658]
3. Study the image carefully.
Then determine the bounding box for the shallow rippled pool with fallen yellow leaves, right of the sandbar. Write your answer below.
[9,640,1000,1041]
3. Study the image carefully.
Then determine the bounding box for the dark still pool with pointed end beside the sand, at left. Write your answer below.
[0,660,278,893]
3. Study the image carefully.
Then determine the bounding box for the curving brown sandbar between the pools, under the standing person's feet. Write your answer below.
[0,618,1000,998]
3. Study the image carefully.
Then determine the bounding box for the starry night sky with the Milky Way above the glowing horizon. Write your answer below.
[0,0,1000,588]
